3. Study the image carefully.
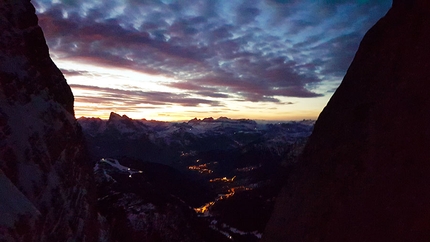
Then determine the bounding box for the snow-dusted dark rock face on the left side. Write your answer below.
[0,0,97,241]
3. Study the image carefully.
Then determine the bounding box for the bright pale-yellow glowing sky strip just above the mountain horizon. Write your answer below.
[59,59,329,122]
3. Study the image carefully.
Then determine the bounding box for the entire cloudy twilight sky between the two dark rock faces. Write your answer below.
[32,0,391,121]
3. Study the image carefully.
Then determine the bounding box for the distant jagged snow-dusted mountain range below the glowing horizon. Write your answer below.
[78,113,313,164]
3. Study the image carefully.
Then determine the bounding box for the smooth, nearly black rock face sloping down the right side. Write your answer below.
[263,0,430,241]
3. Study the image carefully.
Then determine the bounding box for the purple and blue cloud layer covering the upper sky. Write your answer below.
[35,0,390,106]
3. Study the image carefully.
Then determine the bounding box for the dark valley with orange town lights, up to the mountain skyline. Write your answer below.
[78,113,313,241]
